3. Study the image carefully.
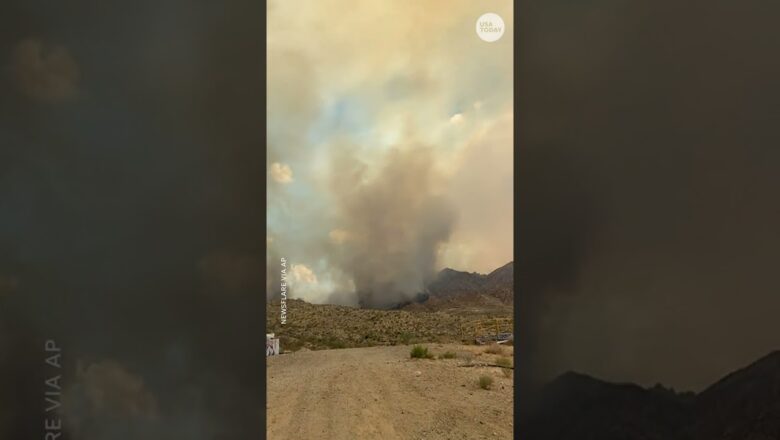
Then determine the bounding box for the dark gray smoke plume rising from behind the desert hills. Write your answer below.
[331,145,456,307]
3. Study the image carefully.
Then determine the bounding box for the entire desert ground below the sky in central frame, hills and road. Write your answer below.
[266,264,513,440]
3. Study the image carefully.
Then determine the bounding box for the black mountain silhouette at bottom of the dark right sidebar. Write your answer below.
[518,352,780,440]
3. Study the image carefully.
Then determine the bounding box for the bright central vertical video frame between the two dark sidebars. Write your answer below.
[265,0,514,440]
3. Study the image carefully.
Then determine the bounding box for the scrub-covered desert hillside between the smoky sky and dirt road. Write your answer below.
[266,263,514,351]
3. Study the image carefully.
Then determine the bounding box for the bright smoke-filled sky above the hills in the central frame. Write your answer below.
[267,0,513,307]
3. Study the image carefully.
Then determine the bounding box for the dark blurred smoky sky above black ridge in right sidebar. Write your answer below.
[515,0,780,391]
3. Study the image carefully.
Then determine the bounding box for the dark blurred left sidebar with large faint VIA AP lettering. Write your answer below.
[0,0,265,440]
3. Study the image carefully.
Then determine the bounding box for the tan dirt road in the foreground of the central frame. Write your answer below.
[267,344,512,440]
